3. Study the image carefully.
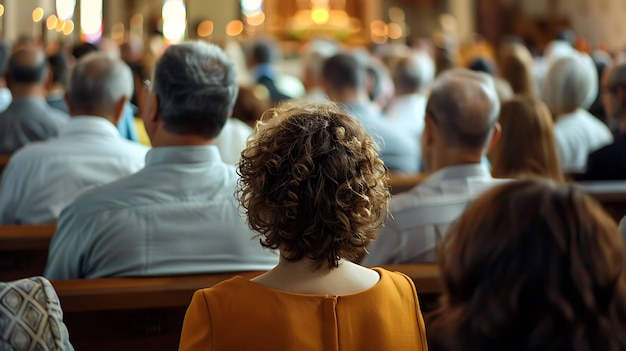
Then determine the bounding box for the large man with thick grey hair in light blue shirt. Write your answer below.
[45,42,278,279]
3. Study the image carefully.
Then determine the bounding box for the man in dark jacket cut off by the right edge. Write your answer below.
[580,63,626,180]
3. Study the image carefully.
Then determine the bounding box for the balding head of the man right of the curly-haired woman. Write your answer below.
[426,69,500,150]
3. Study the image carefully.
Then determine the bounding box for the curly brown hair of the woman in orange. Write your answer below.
[237,105,390,269]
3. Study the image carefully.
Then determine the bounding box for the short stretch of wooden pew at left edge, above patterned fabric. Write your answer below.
[0,224,56,281]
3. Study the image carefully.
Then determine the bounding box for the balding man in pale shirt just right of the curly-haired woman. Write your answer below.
[364,69,500,265]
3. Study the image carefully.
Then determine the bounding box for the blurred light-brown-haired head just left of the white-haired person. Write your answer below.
[498,43,536,97]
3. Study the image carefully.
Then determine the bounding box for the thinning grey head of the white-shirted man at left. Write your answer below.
[68,52,134,117]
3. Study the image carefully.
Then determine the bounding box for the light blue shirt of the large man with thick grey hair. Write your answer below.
[45,146,278,279]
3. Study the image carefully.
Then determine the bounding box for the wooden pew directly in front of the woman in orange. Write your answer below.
[52,265,441,351]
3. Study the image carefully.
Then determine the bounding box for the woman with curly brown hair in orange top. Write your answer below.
[180,105,427,351]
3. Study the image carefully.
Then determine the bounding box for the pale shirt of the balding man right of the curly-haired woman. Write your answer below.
[363,164,508,266]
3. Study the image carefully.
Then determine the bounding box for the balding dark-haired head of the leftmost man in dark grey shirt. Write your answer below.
[6,46,48,85]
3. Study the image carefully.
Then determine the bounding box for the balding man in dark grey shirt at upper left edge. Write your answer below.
[0,46,69,153]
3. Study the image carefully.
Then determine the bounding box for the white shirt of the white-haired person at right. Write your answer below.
[554,109,613,173]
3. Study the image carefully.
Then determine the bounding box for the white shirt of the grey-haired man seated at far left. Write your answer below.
[0,116,148,224]
